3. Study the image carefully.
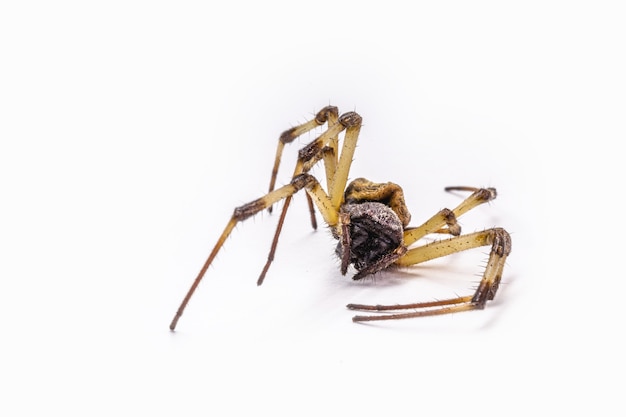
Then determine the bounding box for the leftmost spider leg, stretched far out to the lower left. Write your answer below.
[170,174,332,330]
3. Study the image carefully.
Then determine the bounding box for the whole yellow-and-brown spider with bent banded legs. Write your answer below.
[170,106,511,331]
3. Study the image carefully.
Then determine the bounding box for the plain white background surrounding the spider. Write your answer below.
[0,1,626,416]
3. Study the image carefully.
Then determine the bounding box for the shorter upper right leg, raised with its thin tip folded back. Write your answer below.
[404,187,497,246]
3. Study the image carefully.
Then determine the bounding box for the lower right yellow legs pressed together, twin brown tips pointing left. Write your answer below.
[347,228,511,322]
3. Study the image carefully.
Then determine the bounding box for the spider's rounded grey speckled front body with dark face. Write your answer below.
[336,202,404,279]
